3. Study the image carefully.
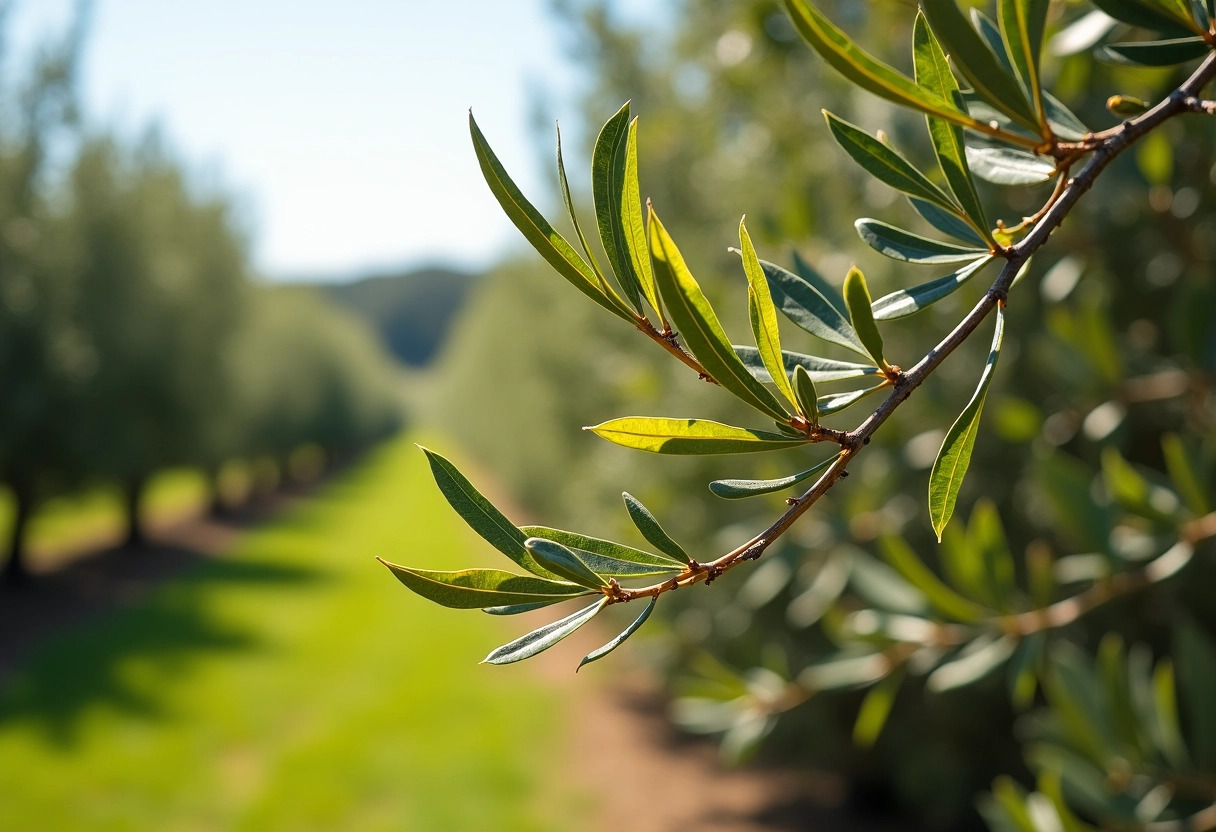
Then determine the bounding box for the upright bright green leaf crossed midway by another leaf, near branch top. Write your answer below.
[912,11,989,242]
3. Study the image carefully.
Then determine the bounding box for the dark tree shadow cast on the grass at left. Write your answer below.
[0,546,327,746]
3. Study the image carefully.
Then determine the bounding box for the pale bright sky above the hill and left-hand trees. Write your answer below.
[12,0,612,277]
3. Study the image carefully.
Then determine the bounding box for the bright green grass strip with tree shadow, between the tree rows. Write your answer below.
[0,439,585,831]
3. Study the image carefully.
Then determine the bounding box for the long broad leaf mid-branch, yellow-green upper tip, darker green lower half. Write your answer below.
[649,209,788,421]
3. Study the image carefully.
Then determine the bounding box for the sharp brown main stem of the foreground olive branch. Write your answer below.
[608,52,1216,603]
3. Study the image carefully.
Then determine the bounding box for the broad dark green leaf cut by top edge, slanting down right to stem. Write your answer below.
[922,0,1040,133]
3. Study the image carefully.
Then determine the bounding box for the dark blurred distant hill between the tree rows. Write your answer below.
[317,268,480,367]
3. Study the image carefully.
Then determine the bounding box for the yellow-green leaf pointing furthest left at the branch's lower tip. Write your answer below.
[376,558,587,609]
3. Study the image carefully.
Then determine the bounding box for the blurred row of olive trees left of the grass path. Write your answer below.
[0,17,398,579]
